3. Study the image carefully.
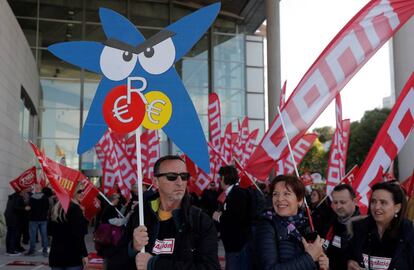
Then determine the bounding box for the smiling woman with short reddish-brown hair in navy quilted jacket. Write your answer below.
[254,175,329,270]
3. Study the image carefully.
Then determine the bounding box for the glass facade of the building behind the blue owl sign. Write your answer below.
[9,0,254,175]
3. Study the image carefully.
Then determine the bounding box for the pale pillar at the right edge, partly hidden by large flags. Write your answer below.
[392,17,414,181]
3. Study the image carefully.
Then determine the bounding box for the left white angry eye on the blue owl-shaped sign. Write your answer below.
[100,46,138,81]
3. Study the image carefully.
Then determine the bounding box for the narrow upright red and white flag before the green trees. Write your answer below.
[326,119,351,194]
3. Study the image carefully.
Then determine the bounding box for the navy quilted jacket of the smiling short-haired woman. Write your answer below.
[253,212,317,270]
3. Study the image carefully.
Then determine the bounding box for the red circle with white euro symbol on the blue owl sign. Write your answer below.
[103,85,145,134]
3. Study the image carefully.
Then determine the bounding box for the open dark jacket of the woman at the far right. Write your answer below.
[348,216,414,270]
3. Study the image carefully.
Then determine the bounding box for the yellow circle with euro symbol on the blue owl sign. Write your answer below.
[142,91,172,130]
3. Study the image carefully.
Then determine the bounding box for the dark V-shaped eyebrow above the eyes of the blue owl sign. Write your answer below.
[102,29,175,54]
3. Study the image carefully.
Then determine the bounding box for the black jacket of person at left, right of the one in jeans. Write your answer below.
[49,202,88,267]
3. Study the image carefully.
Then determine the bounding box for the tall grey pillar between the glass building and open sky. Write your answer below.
[266,0,281,123]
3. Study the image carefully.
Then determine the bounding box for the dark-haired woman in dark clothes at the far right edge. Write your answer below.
[348,182,414,270]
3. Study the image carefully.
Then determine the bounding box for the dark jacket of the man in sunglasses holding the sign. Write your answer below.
[101,193,220,270]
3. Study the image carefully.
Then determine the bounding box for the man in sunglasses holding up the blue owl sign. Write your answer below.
[106,155,220,270]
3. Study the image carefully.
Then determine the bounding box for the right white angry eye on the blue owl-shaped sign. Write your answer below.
[138,38,175,75]
